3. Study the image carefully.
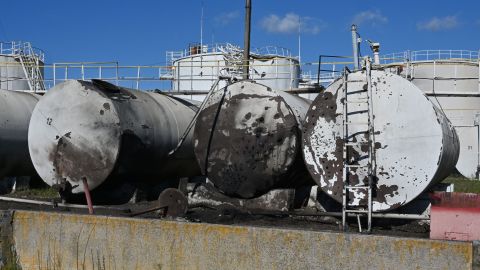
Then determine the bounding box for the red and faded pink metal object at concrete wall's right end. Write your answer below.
[430,192,480,241]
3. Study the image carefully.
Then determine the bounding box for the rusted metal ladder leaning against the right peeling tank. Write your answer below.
[342,58,375,233]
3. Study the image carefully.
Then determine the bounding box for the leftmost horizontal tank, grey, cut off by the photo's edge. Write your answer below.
[0,90,40,179]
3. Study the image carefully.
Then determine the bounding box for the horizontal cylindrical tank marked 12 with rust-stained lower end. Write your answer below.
[28,80,199,197]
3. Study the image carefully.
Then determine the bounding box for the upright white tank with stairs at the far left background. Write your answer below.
[0,41,44,91]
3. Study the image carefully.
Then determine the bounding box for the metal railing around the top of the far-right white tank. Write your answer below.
[380,50,479,64]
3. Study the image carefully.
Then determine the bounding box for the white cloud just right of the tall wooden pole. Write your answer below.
[260,13,325,35]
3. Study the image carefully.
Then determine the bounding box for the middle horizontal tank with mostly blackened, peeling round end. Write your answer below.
[194,81,310,198]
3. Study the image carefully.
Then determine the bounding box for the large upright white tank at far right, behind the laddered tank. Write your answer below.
[386,50,480,179]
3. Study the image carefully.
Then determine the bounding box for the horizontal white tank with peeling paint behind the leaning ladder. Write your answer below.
[303,70,459,211]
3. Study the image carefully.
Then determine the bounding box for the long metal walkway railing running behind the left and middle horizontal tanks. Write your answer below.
[0,60,342,91]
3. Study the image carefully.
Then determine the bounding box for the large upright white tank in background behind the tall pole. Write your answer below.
[171,44,300,100]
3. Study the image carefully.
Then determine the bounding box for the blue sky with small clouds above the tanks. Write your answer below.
[0,0,480,65]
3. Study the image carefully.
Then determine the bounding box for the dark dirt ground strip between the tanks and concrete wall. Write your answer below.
[0,194,429,238]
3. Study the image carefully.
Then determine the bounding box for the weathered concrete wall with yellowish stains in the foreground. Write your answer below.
[8,211,474,270]
